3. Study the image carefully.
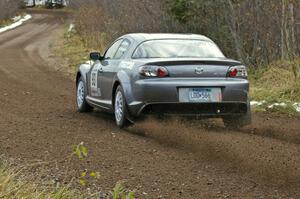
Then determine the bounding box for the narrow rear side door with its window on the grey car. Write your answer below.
[99,39,131,105]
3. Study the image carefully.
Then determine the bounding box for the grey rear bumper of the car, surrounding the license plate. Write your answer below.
[127,78,249,116]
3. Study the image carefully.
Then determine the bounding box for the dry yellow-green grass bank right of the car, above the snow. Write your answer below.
[250,59,300,102]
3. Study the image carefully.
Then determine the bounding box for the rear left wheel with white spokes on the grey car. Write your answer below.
[114,86,129,128]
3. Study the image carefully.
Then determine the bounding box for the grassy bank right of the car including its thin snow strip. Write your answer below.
[249,58,300,117]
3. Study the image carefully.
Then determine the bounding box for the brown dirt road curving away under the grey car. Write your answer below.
[0,13,300,199]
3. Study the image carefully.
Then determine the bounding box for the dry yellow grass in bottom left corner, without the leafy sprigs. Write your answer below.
[0,156,135,199]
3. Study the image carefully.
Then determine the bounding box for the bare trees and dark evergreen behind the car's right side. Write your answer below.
[169,0,300,66]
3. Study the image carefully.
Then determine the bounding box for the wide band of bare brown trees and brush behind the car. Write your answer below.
[69,0,300,66]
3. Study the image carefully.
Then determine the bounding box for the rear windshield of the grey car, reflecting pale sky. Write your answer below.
[132,39,224,59]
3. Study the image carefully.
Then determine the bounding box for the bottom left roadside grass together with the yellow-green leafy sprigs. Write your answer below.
[0,143,135,199]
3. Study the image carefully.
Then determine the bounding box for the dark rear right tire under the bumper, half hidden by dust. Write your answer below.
[223,103,252,130]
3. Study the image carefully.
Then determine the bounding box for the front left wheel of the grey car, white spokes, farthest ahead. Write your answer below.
[76,77,93,113]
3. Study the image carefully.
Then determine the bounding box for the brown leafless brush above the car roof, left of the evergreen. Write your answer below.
[71,0,183,52]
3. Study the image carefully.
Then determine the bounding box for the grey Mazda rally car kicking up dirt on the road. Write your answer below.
[76,34,251,128]
